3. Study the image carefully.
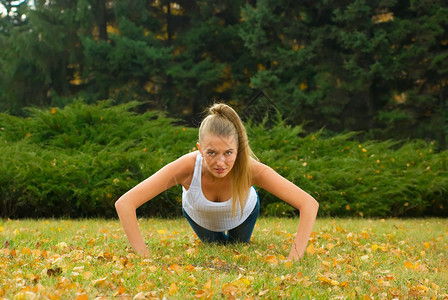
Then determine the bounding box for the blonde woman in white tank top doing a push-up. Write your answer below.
[115,104,319,260]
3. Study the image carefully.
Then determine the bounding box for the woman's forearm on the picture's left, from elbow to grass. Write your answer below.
[115,201,149,256]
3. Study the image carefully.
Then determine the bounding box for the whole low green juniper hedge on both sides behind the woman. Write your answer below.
[0,101,448,218]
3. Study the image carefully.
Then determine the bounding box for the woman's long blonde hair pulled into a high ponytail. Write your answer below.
[199,103,254,215]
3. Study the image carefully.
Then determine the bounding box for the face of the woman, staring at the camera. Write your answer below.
[198,134,238,178]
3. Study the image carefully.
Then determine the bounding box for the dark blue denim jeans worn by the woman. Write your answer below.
[182,196,260,244]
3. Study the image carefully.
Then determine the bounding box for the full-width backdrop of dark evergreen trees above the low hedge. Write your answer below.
[0,0,448,148]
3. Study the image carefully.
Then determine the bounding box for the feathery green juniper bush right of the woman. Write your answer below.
[248,119,448,217]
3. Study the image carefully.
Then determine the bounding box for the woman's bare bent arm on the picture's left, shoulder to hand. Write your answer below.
[115,153,196,256]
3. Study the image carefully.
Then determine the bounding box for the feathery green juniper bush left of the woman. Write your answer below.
[0,102,196,217]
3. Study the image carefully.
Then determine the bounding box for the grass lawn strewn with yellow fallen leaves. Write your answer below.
[0,218,448,300]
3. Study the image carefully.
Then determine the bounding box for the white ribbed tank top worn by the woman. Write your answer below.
[182,152,258,232]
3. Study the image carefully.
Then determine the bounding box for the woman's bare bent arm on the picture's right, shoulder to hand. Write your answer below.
[252,160,319,260]
